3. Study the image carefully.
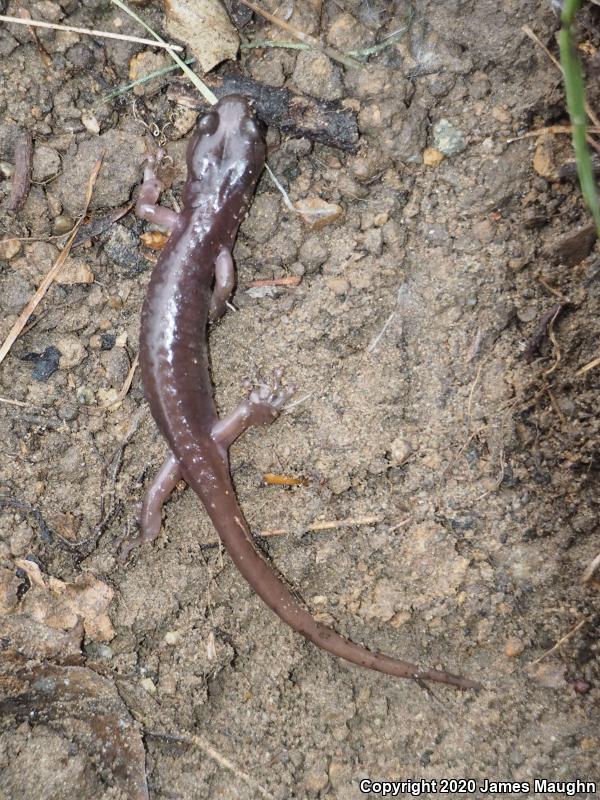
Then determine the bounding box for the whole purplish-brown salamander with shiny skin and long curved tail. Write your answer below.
[122,96,479,689]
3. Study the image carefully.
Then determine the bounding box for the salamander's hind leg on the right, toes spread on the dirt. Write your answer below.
[212,370,294,450]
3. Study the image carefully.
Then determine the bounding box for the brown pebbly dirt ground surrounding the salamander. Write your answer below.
[0,0,600,800]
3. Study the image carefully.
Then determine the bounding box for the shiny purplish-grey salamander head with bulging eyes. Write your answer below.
[183,95,265,206]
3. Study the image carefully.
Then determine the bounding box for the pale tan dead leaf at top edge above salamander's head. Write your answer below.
[165,0,240,72]
